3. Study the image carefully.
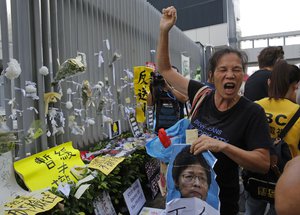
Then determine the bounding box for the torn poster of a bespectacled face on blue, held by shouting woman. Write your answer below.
[166,144,220,212]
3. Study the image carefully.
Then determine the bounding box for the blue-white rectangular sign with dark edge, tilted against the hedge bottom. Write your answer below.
[123,179,146,215]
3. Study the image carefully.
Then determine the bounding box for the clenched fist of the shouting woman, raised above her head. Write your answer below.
[160,6,177,32]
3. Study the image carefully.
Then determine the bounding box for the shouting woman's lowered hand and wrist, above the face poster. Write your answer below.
[191,134,227,155]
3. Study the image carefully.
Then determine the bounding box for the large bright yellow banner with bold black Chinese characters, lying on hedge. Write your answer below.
[14,142,85,191]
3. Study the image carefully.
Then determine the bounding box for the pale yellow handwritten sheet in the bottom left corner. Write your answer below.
[4,192,63,215]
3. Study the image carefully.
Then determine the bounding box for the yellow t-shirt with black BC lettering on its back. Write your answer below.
[256,98,300,157]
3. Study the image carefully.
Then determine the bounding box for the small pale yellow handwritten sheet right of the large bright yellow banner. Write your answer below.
[89,156,125,175]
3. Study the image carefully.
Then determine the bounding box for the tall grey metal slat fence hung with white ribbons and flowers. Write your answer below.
[0,0,204,157]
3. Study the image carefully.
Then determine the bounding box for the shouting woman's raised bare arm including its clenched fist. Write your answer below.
[157,6,189,96]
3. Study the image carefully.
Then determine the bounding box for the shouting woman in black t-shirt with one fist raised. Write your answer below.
[157,6,272,215]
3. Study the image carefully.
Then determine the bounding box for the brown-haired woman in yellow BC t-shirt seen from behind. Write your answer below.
[245,60,300,215]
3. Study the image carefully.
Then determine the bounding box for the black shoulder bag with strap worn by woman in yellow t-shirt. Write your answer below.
[242,108,300,204]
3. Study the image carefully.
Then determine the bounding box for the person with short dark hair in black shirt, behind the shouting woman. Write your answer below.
[244,46,284,101]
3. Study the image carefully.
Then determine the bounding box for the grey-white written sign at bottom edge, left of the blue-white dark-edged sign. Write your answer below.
[93,191,117,215]
